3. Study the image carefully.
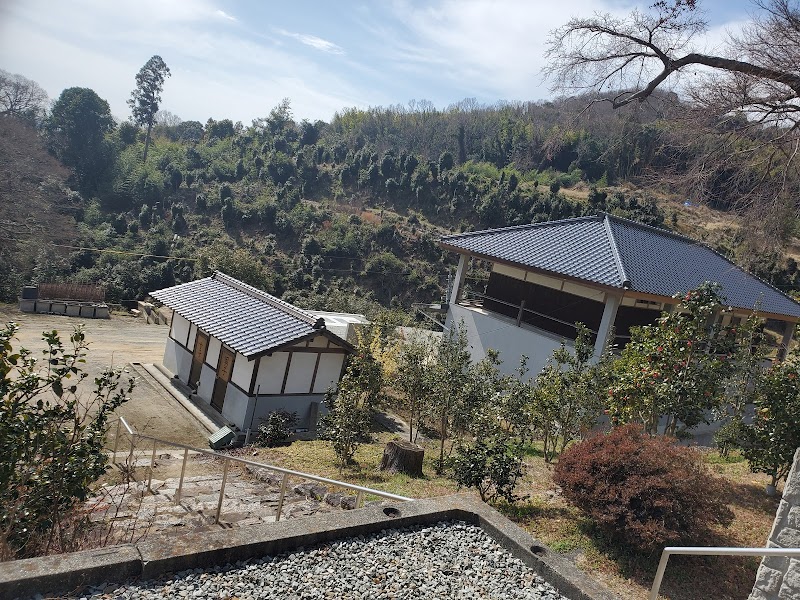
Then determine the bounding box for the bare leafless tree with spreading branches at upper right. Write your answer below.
[544,0,800,232]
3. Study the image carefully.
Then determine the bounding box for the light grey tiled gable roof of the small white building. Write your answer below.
[150,271,347,357]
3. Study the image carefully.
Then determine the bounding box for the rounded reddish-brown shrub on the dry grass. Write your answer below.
[553,424,733,550]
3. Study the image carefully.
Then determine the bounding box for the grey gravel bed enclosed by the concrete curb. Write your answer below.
[54,521,566,600]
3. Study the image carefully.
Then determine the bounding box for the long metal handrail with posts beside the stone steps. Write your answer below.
[112,417,414,523]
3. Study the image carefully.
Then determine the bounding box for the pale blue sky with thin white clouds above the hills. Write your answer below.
[0,0,752,125]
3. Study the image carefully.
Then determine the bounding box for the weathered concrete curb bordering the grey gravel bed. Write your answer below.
[0,494,618,600]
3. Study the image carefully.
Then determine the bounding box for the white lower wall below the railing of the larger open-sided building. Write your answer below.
[445,304,572,376]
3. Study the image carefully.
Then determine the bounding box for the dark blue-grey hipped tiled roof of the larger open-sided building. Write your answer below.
[442,215,800,317]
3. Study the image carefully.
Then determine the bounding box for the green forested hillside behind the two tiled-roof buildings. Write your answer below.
[0,72,797,313]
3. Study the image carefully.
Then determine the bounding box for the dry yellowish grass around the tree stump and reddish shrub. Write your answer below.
[256,426,778,600]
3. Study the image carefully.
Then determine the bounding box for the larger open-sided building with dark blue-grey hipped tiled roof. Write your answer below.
[440,214,800,373]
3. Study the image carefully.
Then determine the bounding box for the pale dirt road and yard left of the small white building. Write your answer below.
[0,304,208,448]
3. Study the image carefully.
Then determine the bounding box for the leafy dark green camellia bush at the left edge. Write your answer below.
[0,323,134,560]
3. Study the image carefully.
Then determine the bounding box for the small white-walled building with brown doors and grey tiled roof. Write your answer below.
[150,272,353,431]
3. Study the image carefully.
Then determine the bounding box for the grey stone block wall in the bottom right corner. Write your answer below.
[749,448,800,600]
